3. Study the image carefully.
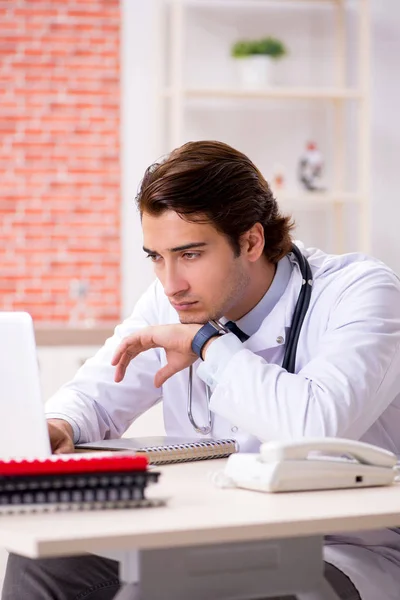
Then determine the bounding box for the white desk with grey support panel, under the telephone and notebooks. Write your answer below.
[0,460,400,600]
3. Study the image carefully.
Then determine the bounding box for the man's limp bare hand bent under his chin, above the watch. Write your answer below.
[111,323,202,387]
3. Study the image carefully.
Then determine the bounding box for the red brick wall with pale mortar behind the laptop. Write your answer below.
[0,0,120,324]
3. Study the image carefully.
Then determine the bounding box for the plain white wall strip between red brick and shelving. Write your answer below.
[121,0,156,317]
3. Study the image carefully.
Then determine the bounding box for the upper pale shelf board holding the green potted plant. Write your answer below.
[162,86,361,100]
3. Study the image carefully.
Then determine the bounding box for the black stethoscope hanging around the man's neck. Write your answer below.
[187,244,313,435]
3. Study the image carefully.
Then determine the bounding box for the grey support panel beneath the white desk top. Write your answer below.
[99,536,339,600]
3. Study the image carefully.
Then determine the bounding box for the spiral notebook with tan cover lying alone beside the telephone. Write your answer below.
[76,436,238,465]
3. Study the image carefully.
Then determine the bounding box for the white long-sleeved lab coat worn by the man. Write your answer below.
[47,246,400,600]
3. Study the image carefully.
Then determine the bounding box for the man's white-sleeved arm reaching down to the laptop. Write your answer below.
[46,284,161,443]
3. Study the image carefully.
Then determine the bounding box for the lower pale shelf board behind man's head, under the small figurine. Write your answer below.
[274,191,363,211]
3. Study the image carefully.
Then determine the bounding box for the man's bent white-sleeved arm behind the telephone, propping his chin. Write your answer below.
[200,269,400,440]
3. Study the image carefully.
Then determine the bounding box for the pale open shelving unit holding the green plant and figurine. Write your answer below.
[157,0,370,252]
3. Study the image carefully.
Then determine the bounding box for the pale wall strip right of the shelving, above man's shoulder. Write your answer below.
[371,0,400,274]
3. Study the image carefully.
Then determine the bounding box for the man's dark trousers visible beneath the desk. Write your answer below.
[2,554,361,600]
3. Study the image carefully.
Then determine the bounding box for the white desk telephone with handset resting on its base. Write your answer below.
[216,438,397,492]
